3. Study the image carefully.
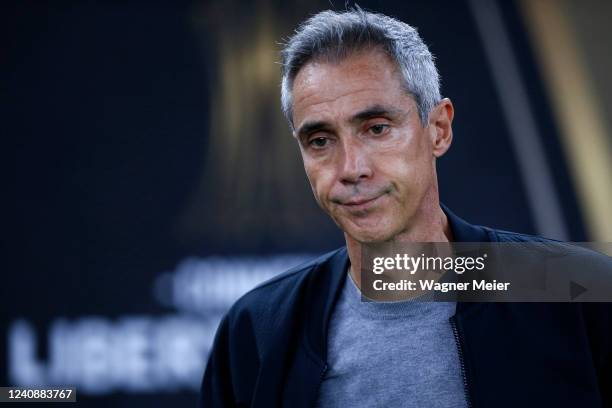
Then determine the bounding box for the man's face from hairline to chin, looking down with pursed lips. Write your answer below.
[293,50,452,242]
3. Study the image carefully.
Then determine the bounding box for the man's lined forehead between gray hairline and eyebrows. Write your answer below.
[293,50,412,126]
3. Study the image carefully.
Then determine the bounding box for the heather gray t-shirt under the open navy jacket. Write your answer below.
[316,274,467,408]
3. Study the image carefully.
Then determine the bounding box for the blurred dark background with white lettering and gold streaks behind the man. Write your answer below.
[0,0,612,407]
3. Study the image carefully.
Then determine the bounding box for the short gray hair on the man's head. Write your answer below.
[281,6,441,128]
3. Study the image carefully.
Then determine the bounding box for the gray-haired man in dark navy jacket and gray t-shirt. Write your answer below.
[201,9,612,407]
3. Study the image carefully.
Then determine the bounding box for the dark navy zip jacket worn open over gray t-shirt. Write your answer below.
[200,209,612,408]
